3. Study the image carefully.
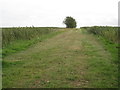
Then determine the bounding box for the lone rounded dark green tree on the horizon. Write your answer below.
[63,16,77,28]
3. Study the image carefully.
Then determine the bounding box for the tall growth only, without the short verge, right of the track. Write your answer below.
[83,26,119,43]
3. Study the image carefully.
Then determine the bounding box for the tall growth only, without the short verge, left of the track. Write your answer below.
[2,27,55,47]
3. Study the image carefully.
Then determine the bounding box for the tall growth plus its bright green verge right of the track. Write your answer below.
[82,26,120,64]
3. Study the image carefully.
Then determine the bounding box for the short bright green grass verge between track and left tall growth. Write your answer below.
[2,31,64,58]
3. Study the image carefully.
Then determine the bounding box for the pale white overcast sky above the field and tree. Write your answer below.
[0,0,119,27]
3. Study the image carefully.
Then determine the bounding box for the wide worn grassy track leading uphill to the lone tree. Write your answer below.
[3,30,117,88]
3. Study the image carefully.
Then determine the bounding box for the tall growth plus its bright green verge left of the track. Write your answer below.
[2,27,59,58]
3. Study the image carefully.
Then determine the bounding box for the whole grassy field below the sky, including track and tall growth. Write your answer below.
[2,27,119,88]
